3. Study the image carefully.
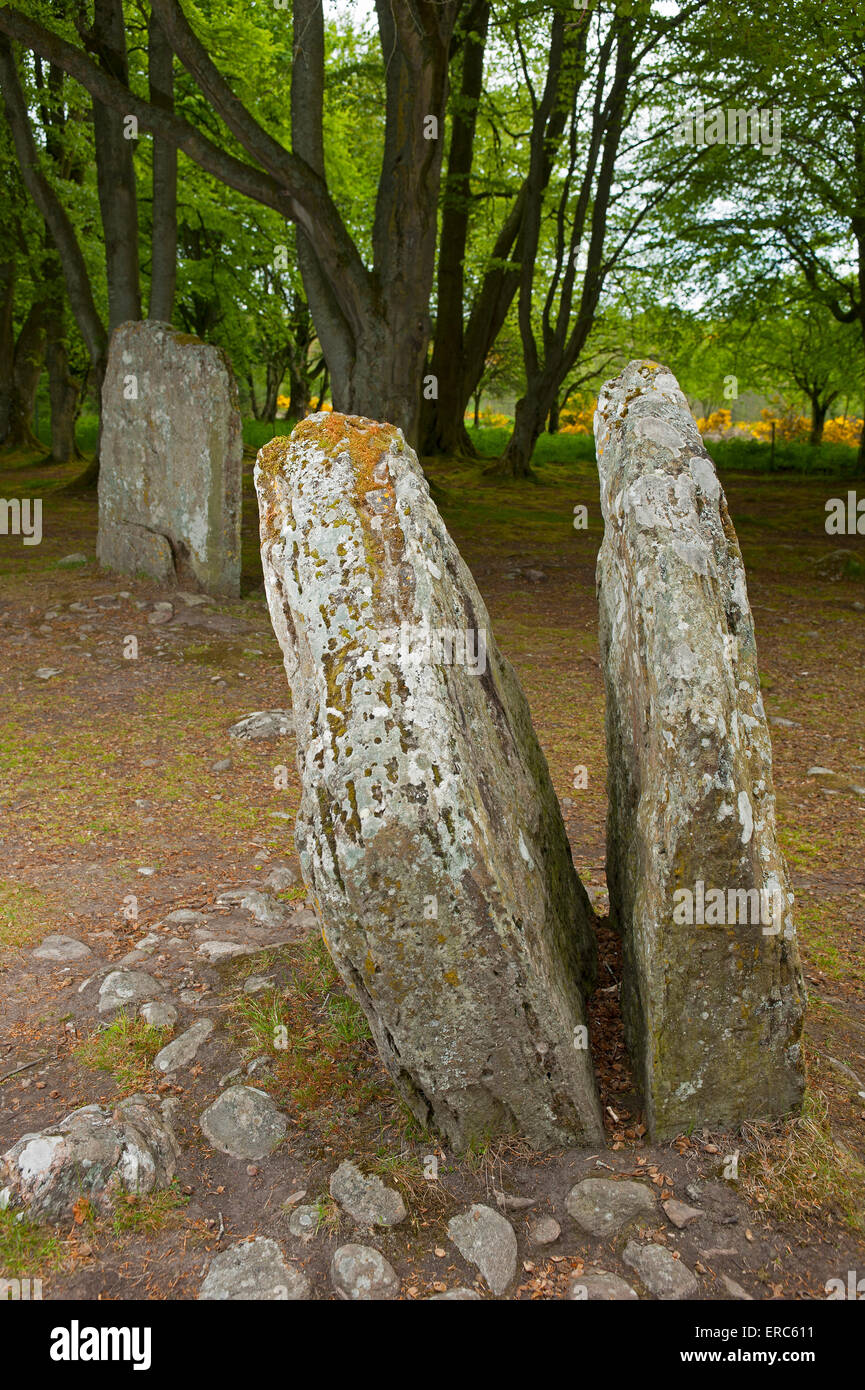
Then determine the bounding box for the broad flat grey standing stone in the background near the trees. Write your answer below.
[96,320,243,595]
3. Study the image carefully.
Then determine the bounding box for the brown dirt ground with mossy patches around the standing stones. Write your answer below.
[0,457,865,1300]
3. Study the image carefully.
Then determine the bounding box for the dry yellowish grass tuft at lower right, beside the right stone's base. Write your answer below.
[741,1090,865,1233]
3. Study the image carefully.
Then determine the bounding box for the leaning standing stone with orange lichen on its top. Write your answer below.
[256,414,602,1148]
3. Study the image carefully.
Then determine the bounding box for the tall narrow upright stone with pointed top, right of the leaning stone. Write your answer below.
[595,361,804,1138]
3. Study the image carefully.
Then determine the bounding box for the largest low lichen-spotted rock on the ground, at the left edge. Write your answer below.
[0,1095,179,1222]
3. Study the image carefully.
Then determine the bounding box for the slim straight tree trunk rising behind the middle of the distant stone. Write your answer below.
[147,14,177,324]
